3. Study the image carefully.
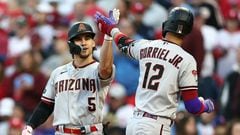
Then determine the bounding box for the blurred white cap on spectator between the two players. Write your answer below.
[109,83,126,99]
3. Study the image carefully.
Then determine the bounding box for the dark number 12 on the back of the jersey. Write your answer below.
[142,62,164,90]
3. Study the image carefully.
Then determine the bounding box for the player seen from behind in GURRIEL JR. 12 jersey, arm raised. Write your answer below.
[95,7,214,135]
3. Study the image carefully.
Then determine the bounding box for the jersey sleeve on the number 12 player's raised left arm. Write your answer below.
[127,39,149,60]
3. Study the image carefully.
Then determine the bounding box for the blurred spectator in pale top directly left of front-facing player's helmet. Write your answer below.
[41,31,72,76]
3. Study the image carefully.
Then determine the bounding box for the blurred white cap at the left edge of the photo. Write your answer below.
[0,98,15,116]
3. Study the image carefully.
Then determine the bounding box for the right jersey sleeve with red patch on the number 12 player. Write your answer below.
[178,57,198,91]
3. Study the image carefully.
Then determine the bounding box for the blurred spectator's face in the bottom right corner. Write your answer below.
[227,119,240,135]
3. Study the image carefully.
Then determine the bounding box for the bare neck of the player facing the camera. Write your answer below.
[73,54,94,68]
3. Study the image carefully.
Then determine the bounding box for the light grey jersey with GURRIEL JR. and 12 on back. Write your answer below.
[128,40,197,119]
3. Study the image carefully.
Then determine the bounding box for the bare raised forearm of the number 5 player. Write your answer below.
[99,38,113,79]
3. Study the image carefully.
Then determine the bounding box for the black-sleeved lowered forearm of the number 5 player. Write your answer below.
[27,101,54,129]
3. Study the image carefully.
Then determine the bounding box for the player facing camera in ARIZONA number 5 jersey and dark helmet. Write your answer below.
[22,10,119,135]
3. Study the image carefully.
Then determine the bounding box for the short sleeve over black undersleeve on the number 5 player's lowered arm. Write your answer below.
[41,71,55,104]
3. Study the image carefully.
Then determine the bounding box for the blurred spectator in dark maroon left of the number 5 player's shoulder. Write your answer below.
[5,51,46,118]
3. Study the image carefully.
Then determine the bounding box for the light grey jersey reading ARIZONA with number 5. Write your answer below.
[41,62,115,126]
